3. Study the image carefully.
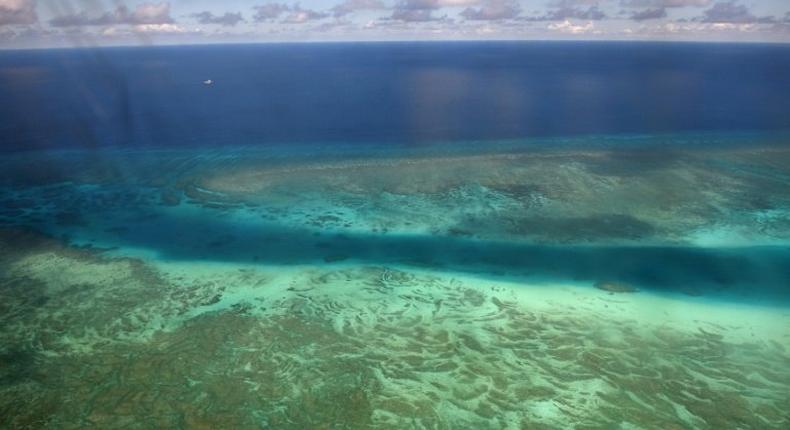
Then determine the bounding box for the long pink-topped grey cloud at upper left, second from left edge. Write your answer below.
[49,2,174,27]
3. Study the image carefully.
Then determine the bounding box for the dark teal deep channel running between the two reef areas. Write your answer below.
[65,208,790,302]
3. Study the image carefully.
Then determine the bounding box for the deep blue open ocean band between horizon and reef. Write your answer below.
[0,42,790,149]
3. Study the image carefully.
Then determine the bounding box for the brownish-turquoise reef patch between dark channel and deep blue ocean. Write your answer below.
[175,139,790,245]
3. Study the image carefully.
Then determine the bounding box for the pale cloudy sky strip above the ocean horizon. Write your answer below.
[0,0,790,49]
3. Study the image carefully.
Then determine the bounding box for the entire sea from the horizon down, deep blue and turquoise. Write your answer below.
[0,42,790,429]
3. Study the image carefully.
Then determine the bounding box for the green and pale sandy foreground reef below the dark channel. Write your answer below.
[0,229,790,429]
